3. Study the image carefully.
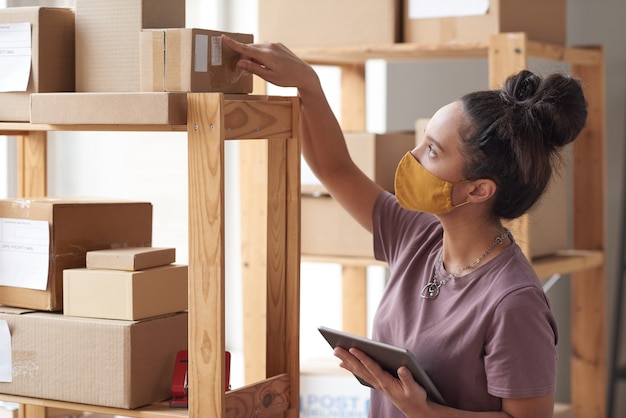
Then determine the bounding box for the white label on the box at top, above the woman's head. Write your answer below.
[409,0,489,19]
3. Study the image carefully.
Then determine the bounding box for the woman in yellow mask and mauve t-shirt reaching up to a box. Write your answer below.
[223,38,587,418]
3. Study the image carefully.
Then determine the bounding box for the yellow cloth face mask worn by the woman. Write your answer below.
[394,151,469,215]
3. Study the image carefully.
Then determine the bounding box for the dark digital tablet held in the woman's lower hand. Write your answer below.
[318,327,446,405]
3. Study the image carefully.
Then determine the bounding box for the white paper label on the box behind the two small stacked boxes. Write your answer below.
[0,218,50,290]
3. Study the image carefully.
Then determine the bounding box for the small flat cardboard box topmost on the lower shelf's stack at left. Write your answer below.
[87,247,176,271]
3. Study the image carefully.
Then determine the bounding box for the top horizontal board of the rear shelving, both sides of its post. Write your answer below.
[294,41,602,65]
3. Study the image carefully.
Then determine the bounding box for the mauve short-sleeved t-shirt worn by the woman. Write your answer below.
[370,193,557,418]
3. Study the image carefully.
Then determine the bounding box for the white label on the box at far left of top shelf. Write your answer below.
[0,23,32,92]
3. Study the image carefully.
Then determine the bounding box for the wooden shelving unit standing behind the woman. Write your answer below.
[288,33,606,418]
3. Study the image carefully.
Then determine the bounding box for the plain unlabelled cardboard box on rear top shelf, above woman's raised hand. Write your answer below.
[259,0,401,48]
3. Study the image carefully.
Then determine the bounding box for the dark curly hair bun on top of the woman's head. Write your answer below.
[501,70,587,148]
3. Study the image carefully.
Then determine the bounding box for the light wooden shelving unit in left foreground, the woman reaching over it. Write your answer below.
[0,93,300,418]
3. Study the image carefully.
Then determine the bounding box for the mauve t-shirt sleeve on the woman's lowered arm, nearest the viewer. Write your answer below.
[485,286,558,398]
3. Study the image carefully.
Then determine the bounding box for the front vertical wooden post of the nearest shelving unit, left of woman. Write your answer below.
[187,93,225,418]
